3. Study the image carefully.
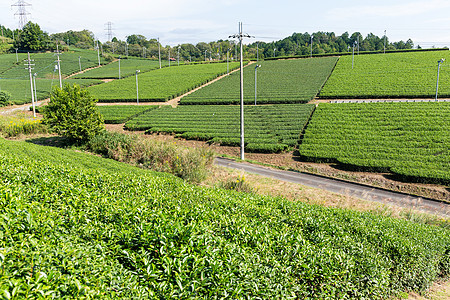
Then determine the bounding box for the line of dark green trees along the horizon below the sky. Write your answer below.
[0,22,420,61]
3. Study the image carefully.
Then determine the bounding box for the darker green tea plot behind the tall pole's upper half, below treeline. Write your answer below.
[180,57,337,104]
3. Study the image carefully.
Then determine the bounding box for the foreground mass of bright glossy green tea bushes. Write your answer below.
[0,140,450,299]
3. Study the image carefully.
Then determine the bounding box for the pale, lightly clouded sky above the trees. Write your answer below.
[0,0,450,48]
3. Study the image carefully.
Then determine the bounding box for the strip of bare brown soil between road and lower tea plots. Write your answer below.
[106,124,450,202]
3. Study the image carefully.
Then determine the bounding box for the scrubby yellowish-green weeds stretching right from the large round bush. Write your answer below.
[88,132,214,182]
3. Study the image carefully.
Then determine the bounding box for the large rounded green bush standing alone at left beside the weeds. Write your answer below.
[43,84,104,142]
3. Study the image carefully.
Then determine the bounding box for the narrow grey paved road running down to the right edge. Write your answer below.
[215,157,450,218]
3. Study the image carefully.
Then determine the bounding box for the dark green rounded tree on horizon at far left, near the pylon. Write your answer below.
[14,22,49,51]
